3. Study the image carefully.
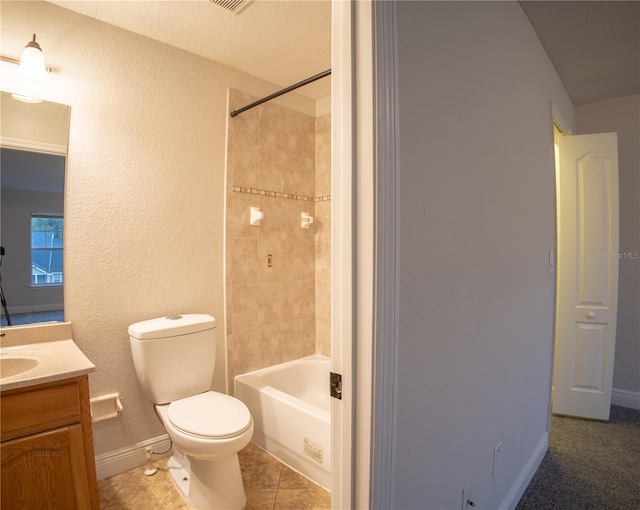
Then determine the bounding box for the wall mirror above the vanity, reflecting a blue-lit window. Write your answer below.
[0,92,70,326]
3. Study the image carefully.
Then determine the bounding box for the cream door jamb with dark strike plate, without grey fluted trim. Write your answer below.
[331,0,375,509]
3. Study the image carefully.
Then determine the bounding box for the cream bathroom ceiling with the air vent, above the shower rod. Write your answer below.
[51,0,331,99]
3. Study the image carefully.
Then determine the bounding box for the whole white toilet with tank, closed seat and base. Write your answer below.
[129,314,253,510]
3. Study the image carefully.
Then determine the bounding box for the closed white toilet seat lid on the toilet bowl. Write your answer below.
[168,391,251,439]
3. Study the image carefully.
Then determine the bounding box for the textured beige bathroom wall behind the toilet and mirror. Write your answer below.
[0,1,315,454]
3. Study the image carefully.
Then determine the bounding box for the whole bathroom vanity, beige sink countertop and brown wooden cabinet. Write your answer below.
[0,327,99,510]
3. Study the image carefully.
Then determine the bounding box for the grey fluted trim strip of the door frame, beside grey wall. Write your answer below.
[370,2,400,508]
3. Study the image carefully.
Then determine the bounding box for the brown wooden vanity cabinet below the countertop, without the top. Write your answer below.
[0,375,100,510]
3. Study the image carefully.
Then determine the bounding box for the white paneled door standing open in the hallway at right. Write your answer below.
[553,133,623,420]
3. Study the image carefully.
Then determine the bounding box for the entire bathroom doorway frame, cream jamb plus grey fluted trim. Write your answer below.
[331,0,388,509]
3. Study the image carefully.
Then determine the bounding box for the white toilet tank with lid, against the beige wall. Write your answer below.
[129,314,216,404]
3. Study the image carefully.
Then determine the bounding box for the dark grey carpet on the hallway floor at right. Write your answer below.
[516,406,640,510]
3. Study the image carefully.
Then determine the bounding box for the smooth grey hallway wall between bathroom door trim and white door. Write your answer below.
[392,2,574,509]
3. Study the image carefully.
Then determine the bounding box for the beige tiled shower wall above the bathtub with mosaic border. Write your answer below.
[226,90,331,391]
